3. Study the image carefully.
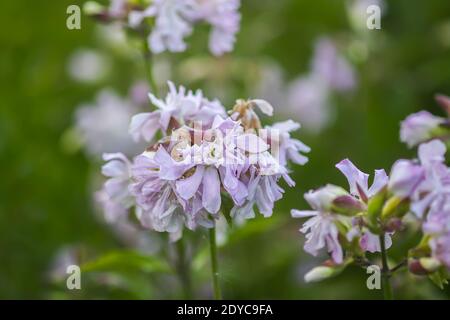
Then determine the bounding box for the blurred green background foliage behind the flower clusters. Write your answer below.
[0,0,450,299]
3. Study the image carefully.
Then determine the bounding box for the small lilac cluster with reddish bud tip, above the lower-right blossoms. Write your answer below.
[400,95,450,147]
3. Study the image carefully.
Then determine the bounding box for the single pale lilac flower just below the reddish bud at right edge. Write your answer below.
[400,111,445,148]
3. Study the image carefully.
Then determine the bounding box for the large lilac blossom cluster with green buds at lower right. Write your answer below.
[292,136,450,281]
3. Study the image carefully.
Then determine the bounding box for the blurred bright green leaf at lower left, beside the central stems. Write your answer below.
[81,250,171,273]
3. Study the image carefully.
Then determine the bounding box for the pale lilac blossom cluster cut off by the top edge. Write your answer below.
[85,0,241,56]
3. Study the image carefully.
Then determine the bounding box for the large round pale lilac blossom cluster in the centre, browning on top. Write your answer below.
[98,82,309,239]
